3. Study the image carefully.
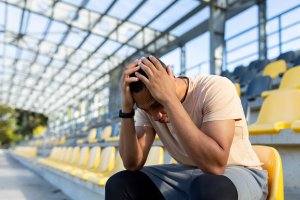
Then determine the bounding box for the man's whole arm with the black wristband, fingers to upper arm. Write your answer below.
[119,60,155,170]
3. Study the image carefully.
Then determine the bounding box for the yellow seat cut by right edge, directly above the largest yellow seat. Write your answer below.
[261,66,300,98]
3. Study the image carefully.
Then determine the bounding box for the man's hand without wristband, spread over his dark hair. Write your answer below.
[136,56,178,105]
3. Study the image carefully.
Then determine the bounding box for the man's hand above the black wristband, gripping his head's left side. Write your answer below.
[121,60,140,112]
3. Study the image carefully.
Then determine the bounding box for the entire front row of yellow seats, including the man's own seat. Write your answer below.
[15,145,284,200]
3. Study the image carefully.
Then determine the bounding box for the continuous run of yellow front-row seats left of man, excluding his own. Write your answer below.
[38,146,164,186]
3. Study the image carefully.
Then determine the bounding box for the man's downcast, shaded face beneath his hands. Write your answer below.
[132,88,169,123]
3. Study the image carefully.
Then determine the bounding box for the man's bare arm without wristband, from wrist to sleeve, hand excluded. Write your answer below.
[165,100,235,174]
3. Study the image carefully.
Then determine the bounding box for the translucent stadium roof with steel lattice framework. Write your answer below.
[0,0,206,114]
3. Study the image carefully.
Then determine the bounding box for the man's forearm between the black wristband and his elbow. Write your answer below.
[119,118,142,170]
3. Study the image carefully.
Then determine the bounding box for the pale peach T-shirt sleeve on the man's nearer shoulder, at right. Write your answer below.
[203,77,243,122]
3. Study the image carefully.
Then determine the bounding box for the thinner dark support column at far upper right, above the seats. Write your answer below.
[258,0,267,60]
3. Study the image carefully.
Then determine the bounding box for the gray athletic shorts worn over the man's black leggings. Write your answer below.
[142,164,268,200]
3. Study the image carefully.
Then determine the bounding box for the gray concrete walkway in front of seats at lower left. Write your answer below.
[0,150,70,200]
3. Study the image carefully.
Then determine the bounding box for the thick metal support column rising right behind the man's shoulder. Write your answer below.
[209,0,227,74]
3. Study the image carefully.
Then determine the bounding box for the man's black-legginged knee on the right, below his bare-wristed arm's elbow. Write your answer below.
[190,174,237,200]
